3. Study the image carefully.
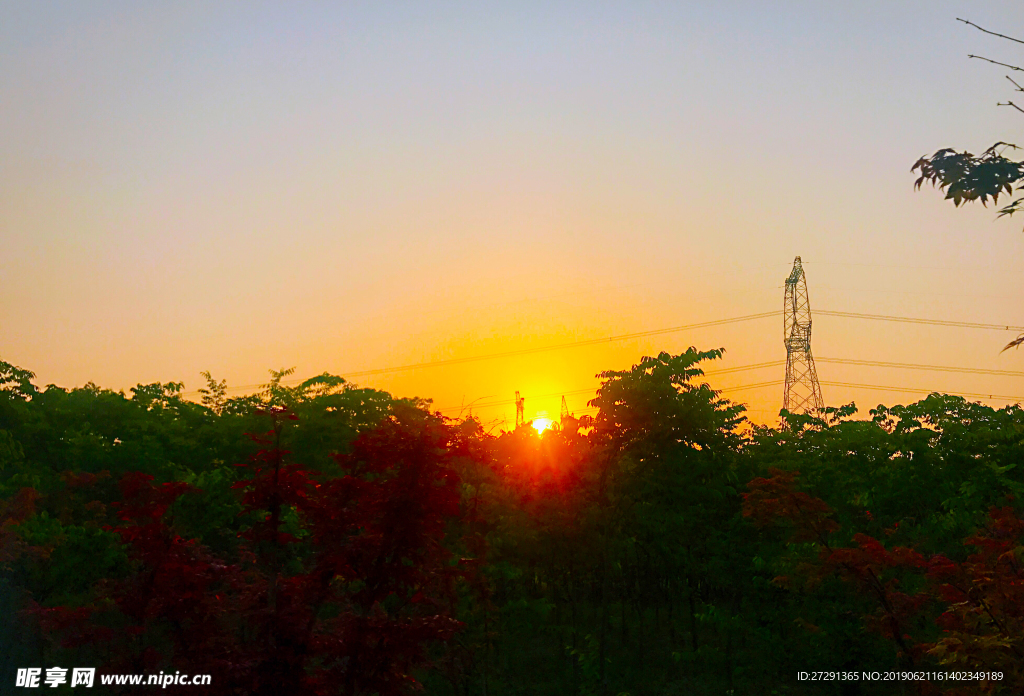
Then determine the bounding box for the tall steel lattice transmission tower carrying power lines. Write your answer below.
[782,256,824,415]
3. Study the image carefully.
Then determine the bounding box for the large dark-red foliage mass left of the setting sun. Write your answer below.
[36,404,471,696]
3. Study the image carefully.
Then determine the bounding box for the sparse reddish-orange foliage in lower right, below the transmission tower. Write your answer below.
[743,470,1024,696]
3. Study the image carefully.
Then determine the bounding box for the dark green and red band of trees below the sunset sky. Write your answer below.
[0,349,1024,696]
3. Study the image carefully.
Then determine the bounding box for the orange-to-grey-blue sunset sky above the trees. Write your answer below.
[0,0,1024,427]
